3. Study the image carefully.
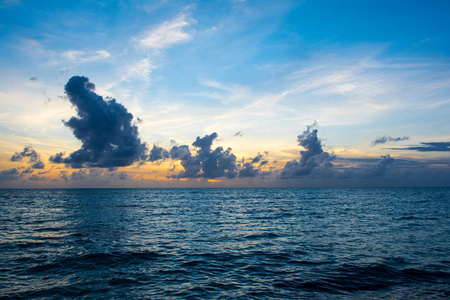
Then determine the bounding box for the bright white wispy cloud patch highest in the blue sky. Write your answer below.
[139,14,192,49]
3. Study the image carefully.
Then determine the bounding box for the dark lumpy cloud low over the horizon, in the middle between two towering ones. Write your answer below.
[169,132,237,179]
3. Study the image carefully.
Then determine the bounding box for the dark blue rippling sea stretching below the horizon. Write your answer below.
[0,189,450,299]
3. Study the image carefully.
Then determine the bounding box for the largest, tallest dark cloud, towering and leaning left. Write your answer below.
[50,76,147,168]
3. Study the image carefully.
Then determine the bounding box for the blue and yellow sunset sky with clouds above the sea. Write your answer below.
[0,0,450,188]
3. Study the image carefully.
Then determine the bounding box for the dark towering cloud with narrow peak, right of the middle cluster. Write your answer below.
[281,123,335,178]
